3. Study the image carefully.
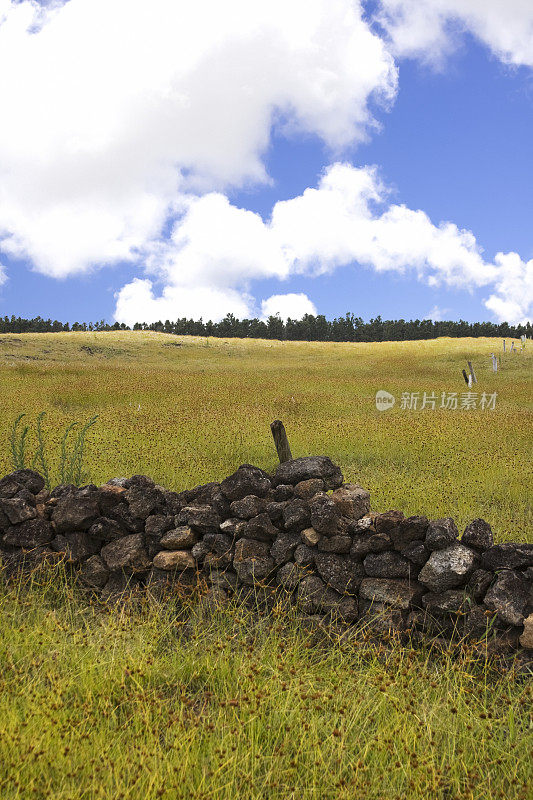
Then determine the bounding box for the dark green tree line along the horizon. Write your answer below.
[0,313,533,342]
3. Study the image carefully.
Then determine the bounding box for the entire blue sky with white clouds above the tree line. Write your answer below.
[0,0,533,323]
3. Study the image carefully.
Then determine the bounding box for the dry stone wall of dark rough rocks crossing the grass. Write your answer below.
[0,456,533,651]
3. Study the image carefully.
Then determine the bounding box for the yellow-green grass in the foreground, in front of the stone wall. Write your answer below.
[0,569,533,800]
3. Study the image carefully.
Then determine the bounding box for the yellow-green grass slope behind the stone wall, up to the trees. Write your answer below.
[0,332,533,541]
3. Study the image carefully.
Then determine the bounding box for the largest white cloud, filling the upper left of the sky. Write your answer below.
[0,0,397,277]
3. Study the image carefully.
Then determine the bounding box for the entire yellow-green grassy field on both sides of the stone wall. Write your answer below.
[0,333,533,800]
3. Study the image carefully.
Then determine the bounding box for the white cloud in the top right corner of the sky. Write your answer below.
[378,0,533,67]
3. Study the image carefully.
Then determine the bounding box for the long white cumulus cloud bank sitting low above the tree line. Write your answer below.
[116,163,533,322]
